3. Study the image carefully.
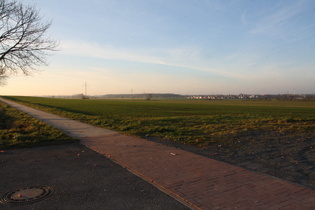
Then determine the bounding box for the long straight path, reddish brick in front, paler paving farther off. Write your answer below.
[1,99,315,209]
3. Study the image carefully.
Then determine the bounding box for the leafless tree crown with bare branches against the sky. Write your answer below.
[0,0,58,76]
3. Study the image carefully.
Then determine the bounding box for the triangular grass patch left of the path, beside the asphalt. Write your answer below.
[0,102,77,149]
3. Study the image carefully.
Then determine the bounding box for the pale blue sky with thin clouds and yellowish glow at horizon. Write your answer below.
[0,0,315,96]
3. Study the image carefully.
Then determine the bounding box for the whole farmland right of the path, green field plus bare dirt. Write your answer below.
[6,97,315,189]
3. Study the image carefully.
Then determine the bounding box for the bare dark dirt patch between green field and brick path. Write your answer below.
[147,131,315,190]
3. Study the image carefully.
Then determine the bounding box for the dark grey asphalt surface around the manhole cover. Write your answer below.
[0,143,188,209]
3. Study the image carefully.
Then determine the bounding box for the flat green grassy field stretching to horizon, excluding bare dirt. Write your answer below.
[5,96,315,147]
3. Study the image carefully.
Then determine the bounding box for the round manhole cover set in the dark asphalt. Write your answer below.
[0,187,54,204]
